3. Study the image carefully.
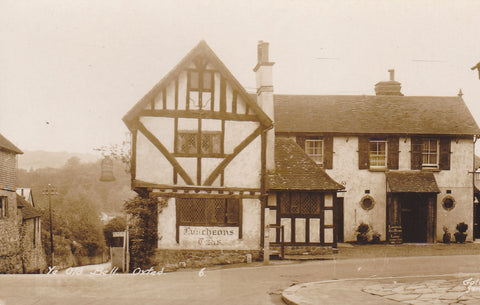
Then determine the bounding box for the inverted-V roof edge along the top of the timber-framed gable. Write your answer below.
[123,40,272,126]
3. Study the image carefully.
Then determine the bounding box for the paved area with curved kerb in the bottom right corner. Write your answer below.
[282,273,480,305]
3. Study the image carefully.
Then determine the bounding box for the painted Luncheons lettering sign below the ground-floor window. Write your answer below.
[180,226,238,248]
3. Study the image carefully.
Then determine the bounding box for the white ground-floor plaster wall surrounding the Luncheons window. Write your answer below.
[158,198,261,250]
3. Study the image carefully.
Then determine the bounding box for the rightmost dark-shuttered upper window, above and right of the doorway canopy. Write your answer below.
[411,137,451,170]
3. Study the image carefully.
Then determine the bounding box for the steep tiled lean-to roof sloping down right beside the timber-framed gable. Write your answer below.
[267,138,344,191]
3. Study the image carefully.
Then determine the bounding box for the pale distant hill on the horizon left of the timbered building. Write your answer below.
[18,150,101,170]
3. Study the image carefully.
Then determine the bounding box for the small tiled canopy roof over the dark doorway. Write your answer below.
[385,171,440,193]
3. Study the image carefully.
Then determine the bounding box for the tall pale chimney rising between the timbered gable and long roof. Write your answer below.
[253,40,275,172]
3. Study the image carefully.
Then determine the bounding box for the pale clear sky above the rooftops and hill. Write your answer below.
[0,0,480,154]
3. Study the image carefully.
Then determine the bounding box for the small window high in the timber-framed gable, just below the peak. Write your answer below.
[188,70,214,110]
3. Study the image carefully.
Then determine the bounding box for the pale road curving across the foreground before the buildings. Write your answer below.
[0,255,480,305]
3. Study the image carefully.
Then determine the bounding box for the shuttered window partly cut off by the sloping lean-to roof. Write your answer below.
[296,135,333,169]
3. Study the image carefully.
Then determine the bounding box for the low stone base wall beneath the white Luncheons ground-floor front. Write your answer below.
[153,249,261,270]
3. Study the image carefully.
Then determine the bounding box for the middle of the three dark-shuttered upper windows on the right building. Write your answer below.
[358,136,399,170]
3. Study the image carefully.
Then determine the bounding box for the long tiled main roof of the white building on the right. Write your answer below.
[266,94,480,135]
